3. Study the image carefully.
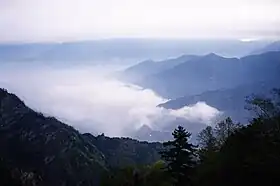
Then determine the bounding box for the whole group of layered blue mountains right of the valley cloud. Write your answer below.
[120,42,280,124]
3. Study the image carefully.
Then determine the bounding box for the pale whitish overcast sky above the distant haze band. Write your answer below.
[0,0,280,42]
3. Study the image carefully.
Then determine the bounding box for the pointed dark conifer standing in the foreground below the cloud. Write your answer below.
[161,126,196,186]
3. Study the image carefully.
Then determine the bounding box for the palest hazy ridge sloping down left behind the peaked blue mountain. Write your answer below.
[119,55,198,83]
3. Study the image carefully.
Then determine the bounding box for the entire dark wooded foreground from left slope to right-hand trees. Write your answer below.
[0,87,280,186]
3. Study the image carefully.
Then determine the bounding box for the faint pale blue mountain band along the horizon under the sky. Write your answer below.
[0,39,267,64]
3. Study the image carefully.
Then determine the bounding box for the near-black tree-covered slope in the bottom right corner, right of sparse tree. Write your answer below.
[194,88,280,186]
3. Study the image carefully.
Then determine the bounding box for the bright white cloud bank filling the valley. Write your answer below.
[0,63,221,136]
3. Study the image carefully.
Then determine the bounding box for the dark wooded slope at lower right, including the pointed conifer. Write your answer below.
[102,89,280,186]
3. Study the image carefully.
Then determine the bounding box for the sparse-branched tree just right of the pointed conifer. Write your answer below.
[193,117,240,186]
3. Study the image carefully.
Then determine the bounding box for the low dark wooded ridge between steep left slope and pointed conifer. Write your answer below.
[83,134,162,167]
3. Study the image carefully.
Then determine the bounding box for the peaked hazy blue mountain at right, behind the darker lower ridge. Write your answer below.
[138,52,280,99]
